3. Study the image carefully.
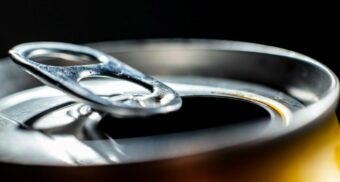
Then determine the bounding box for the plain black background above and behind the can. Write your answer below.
[0,0,340,114]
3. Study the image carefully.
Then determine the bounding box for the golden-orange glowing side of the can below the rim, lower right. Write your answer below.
[168,115,340,182]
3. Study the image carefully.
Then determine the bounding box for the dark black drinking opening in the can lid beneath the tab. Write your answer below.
[98,96,270,138]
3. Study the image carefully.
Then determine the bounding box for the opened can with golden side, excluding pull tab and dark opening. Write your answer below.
[0,39,340,182]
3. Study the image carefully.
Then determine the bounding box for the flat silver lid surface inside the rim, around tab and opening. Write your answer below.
[0,77,304,166]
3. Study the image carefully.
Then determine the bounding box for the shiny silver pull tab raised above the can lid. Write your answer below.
[9,42,182,117]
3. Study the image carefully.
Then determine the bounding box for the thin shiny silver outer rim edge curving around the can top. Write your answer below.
[0,39,339,166]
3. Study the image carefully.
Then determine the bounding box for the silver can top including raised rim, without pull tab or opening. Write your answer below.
[0,40,339,166]
